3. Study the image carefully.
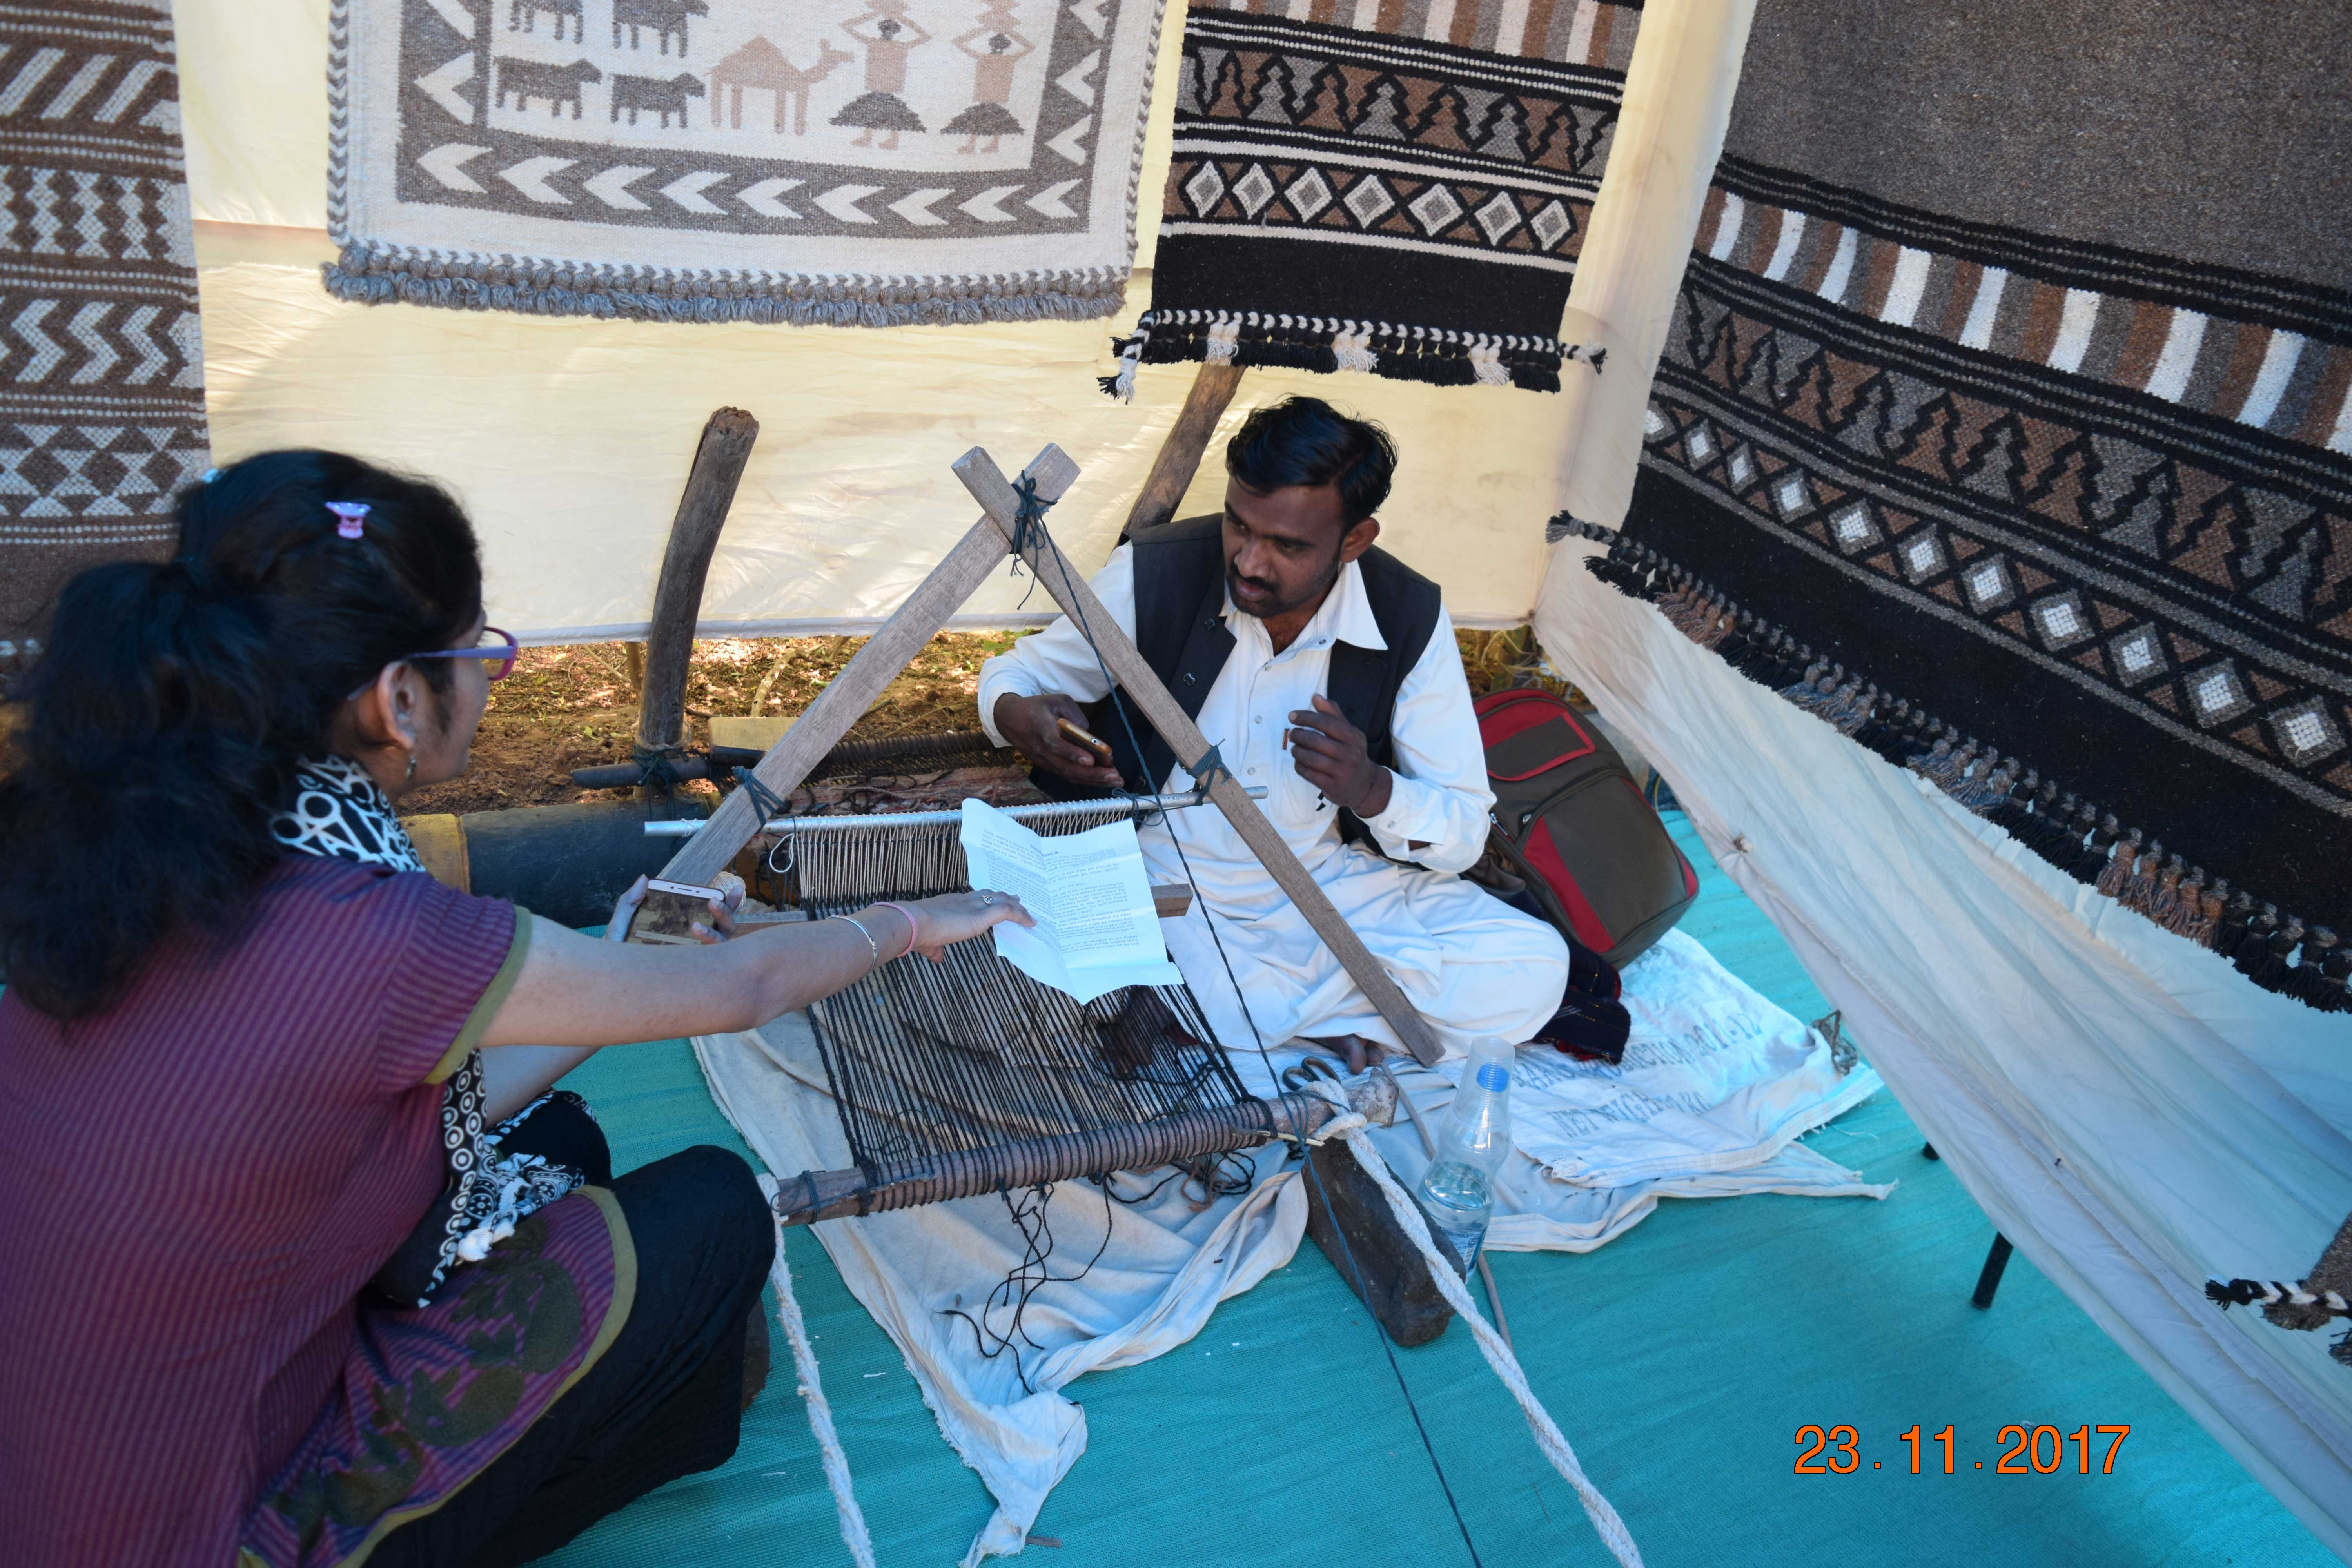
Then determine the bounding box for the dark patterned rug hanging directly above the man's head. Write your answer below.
[1108,0,1642,392]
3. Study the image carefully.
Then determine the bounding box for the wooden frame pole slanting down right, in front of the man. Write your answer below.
[946,446,1442,1067]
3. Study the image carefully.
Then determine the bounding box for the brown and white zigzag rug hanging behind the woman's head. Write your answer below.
[0,0,209,677]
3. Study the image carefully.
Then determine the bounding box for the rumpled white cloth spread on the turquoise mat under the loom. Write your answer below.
[694,922,1886,1568]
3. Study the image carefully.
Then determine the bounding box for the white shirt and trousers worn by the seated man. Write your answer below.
[978,545,1569,1053]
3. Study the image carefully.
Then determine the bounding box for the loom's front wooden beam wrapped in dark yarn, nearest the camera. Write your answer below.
[774,1093,1338,1225]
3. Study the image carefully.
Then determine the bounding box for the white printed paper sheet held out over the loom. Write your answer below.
[962,799,1183,1002]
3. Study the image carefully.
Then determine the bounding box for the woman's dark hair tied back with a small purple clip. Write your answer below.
[0,451,482,1018]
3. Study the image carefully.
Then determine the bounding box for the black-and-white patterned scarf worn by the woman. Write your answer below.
[270,757,586,1307]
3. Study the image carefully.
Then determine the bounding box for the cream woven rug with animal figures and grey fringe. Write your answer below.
[327,0,1164,327]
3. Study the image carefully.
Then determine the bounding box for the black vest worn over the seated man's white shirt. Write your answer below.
[1054,517,1442,842]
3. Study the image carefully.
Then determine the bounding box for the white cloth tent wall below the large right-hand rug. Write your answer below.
[1536,545,2352,1556]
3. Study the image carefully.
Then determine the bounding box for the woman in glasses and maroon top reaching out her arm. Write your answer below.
[0,451,1028,1568]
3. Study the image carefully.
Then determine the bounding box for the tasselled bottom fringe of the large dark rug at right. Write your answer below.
[1545,512,2352,1013]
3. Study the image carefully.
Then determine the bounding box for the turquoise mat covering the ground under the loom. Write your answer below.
[543,813,2333,1568]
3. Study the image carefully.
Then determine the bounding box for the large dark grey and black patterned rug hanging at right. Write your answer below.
[1571,0,2352,1006]
